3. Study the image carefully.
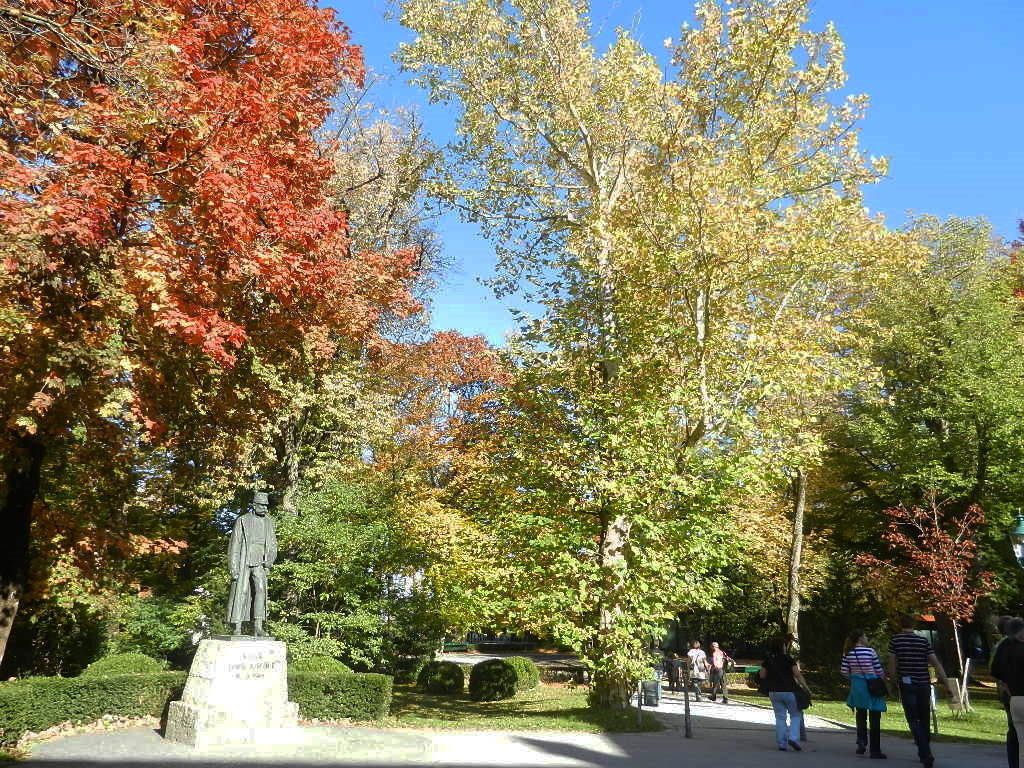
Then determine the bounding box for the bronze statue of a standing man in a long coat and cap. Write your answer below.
[227,492,278,637]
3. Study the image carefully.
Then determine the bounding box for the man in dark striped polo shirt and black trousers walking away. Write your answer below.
[889,613,950,768]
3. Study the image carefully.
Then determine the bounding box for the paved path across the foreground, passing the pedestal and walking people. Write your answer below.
[23,700,1006,768]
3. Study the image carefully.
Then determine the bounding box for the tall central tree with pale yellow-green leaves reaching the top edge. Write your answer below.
[398,0,919,706]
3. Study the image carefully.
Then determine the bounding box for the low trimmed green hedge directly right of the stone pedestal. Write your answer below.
[288,672,392,720]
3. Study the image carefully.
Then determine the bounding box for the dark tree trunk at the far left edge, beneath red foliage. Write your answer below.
[0,435,46,664]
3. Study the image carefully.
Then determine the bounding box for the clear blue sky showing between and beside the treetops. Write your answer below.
[326,0,1024,344]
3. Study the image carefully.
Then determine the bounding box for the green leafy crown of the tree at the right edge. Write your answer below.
[822,217,1024,618]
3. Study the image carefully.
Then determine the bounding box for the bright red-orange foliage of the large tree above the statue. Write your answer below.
[0,0,419,442]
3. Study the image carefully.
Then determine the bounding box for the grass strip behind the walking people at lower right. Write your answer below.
[730,687,1007,743]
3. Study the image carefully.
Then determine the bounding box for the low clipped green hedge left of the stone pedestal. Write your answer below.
[0,671,185,744]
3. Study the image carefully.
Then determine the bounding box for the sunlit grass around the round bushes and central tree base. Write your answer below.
[381,683,663,733]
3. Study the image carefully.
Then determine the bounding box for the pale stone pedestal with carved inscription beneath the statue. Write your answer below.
[166,638,298,746]
